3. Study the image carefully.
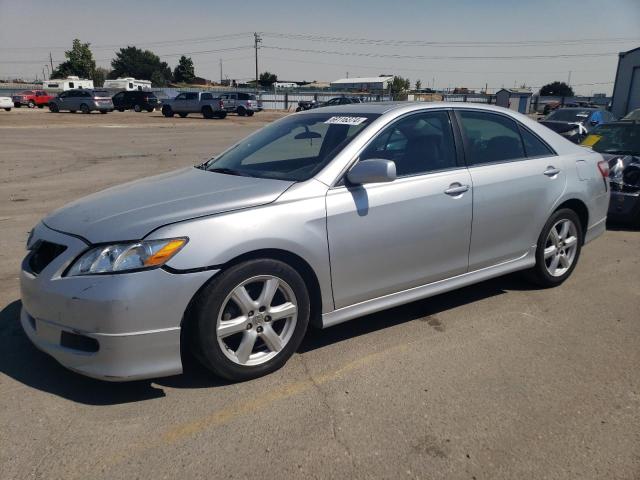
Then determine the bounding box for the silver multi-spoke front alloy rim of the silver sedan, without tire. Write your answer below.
[216,275,298,366]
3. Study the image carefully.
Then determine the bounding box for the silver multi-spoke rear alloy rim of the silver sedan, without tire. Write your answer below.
[544,218,578,277]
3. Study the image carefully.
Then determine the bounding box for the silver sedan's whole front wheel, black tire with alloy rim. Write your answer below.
[188,259,310,381]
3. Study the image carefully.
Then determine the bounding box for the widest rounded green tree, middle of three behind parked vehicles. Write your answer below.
[109,47,172,87]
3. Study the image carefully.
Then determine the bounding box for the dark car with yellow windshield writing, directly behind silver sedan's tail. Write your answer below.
[582,120,640,226]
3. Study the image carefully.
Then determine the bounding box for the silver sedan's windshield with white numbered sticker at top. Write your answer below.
[202,113,379,181]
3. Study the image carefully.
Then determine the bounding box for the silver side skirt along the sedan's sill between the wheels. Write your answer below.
[322,245,536,328]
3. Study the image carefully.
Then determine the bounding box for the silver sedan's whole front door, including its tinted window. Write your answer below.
[327,110,472,308]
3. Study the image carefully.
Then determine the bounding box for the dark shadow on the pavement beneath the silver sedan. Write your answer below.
[0,275,535,406]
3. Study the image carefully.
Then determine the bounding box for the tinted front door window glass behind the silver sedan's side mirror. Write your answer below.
[360,112,456,177]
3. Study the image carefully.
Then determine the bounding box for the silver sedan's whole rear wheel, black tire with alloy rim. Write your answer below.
[527,208,584,288]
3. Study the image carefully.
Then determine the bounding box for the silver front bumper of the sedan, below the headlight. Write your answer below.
[20,224,215,381]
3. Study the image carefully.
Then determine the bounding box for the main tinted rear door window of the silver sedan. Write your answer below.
[459,110,525,165]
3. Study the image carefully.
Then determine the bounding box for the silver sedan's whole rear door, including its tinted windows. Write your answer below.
[456,109,567,271]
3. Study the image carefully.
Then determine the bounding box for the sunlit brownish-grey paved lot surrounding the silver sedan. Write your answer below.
[0,109,640,480]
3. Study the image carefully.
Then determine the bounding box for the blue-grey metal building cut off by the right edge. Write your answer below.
[611,47,640,117]
